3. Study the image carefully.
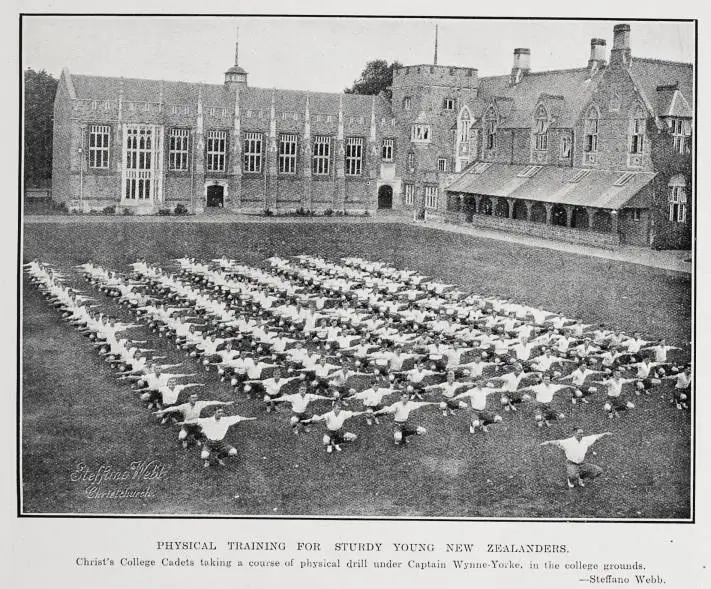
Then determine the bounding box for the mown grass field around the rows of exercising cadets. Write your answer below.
[22,221,691,518]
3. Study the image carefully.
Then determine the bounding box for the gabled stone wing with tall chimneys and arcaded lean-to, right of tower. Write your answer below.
[446,24,694,248]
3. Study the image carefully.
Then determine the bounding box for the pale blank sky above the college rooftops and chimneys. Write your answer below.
[22,16,694,92]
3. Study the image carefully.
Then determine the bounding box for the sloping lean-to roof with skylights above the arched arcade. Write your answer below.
[447,164,655,209]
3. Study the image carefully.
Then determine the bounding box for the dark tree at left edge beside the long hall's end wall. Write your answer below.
[24,68,58,187]
